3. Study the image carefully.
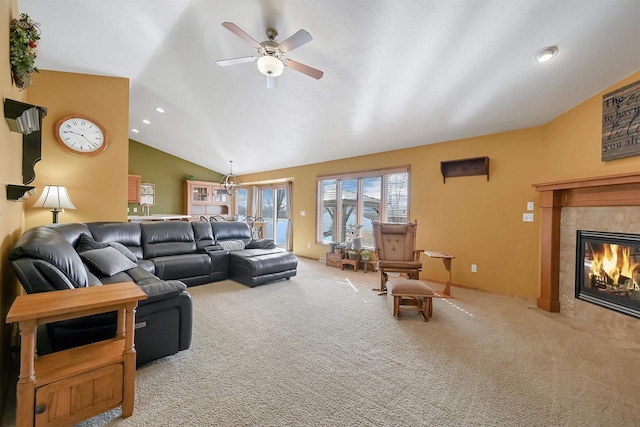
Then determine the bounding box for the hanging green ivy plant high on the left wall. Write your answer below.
[9,13,40,89]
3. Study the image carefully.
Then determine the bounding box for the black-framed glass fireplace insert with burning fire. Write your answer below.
[576,230,640,319]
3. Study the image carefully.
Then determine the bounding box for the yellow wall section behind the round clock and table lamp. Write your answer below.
[25,70,129,228]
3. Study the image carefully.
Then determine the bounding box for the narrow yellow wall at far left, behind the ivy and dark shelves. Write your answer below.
[0,0,26,419]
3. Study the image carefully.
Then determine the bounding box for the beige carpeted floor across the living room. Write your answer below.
[5,259,640,426]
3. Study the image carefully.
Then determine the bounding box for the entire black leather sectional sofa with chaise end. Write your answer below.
[9,221,298,364]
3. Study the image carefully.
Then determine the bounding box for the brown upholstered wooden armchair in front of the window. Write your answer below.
[373,220,422,292]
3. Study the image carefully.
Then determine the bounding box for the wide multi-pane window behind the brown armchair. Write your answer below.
[316,167,409,247]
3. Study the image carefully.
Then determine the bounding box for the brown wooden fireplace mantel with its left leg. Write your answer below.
[533,172,640,312]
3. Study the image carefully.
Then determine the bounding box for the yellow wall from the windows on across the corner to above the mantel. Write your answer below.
[241,67,640,298]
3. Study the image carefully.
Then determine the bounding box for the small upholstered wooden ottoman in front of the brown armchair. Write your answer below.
[387,279,434,322]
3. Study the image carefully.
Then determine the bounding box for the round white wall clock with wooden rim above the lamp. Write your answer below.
[55,114,109,155]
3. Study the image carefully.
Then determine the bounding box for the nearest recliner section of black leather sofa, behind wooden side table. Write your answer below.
[9,224,193,364]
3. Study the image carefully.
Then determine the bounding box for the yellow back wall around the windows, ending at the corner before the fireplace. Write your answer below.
[241,128,542,298]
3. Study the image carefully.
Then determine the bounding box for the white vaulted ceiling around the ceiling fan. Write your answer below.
[19,0,640,174]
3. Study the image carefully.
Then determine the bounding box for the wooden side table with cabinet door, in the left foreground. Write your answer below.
[7,282,147,427]
